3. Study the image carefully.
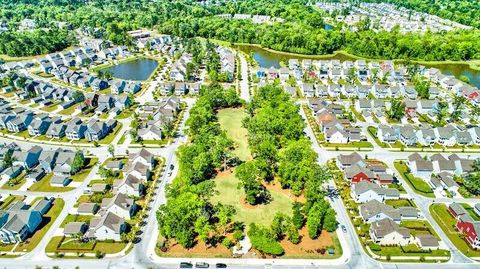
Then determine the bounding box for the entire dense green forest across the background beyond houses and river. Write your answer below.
[0,0,480,60]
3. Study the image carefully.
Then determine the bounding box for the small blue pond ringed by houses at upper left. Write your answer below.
[106,58,158,80]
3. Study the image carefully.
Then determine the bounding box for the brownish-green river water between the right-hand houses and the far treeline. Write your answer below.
[237,45,480,88]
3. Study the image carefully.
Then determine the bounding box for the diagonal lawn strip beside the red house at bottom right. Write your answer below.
[430,204,480,257]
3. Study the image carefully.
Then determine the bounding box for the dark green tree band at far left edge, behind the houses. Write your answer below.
[0,28,76,56]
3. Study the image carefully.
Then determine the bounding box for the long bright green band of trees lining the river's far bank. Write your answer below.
[160,17,480,61]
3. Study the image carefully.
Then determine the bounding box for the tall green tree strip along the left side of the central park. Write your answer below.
[157,86,243,248]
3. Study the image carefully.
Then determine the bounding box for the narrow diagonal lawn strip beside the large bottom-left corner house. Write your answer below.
[17,198,65,251]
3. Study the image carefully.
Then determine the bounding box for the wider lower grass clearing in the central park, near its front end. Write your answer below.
[211,172,293,226]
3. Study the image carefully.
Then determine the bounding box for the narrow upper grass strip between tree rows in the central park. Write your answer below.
[217,108,251,161]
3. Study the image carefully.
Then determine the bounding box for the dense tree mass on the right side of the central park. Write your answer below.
[240,85,337,255]
